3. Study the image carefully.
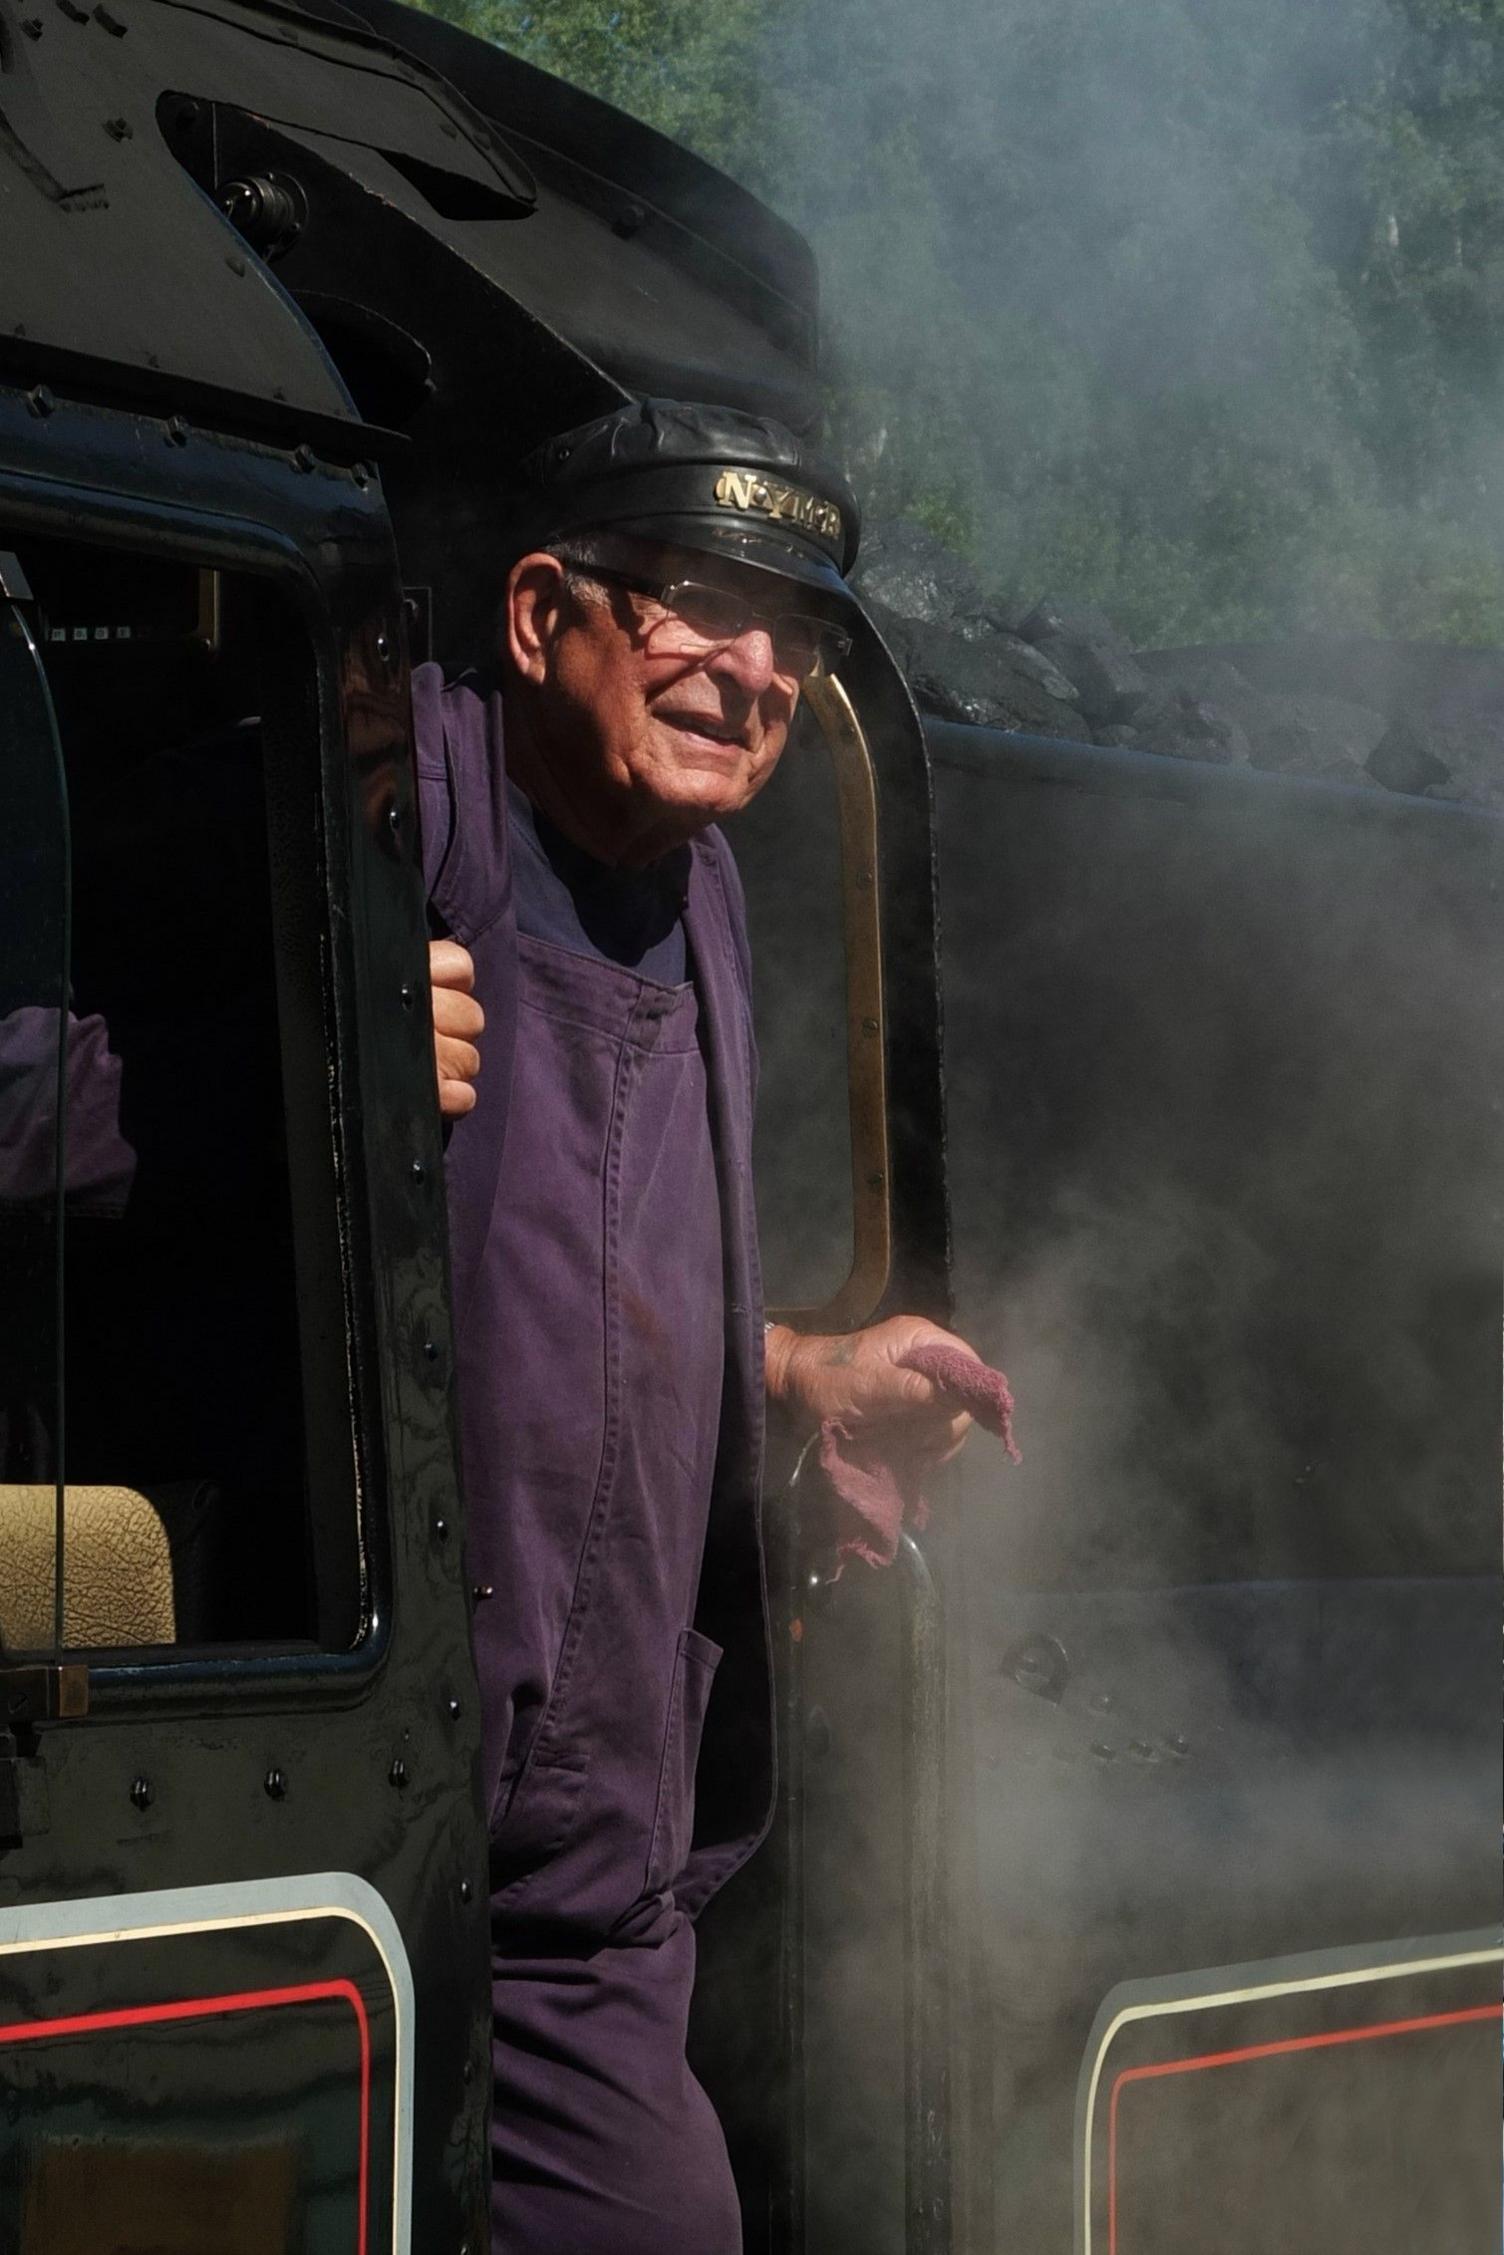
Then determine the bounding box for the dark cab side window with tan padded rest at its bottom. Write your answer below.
[0,534,365,1653]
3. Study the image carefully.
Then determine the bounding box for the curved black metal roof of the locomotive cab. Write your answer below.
[0,0,816,453]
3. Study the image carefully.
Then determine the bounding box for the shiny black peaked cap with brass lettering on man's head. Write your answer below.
[516,399,859,595]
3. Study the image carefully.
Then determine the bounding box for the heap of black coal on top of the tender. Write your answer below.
[857,521,1504,812]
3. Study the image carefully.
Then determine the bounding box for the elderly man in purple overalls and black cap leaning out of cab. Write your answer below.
[413,401,965,2255]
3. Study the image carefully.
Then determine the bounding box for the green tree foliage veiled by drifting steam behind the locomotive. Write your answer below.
[403,0,1504,643]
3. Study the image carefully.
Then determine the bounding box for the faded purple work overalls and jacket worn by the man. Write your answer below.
[413,667,771,2255]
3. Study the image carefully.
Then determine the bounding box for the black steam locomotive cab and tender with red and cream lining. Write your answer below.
[0,0,1499,2255]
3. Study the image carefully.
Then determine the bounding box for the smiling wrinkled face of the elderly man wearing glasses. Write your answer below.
[507,541,829,861]
